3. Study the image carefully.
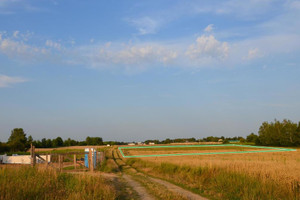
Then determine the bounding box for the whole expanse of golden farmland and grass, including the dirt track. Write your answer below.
[0,145,300,200]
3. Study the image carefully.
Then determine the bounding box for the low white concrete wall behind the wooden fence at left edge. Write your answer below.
[0,155,50,164]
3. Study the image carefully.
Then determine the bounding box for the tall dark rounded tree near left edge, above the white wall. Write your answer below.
[8,128,27,152]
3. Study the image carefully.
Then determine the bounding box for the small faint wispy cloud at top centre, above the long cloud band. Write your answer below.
[128,17,159,35]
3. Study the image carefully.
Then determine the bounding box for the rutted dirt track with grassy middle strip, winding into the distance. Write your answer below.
[69,149,207,200]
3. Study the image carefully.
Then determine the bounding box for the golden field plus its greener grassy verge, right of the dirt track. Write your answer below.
[126,145,300,199]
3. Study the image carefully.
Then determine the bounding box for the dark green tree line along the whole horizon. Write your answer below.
[0,119,300,153]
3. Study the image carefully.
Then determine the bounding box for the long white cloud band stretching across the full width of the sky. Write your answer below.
[0,26,300,70]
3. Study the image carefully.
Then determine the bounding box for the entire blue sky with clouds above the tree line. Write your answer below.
[0,0,300,142]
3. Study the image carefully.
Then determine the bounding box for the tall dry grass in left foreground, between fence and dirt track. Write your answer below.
[0,166,117,200]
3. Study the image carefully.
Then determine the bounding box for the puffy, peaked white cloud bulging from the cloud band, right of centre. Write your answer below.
[186,35,229,60]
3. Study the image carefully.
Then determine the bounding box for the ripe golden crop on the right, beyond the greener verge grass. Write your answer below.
[142,150,300,186]
